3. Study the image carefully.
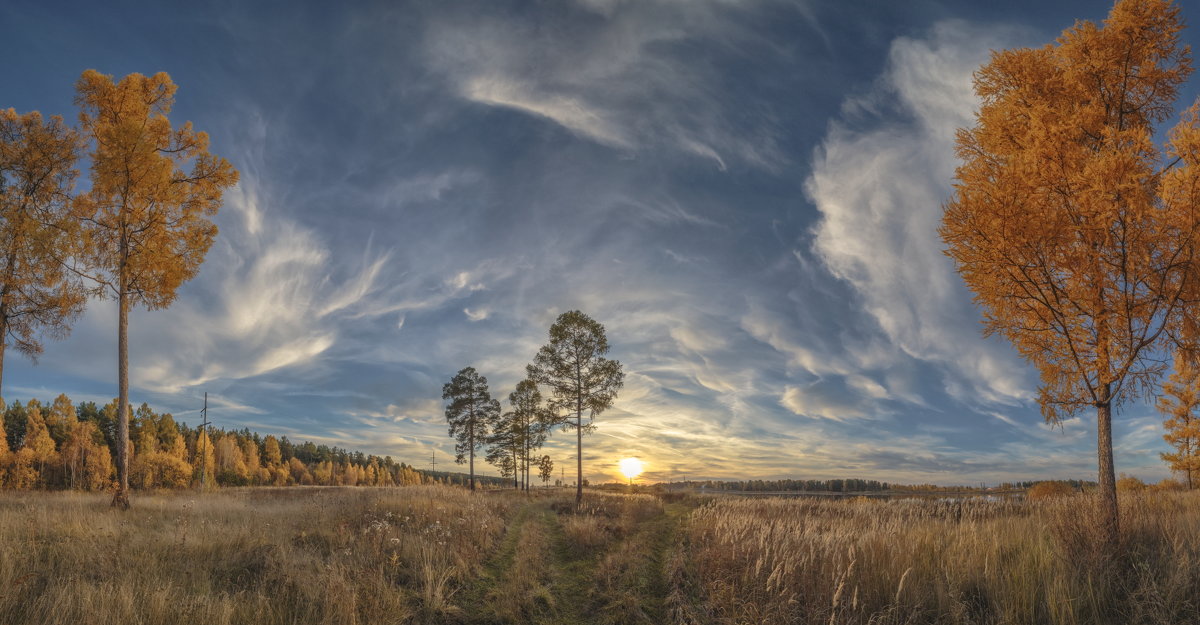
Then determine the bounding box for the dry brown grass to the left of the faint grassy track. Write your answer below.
[0,486,510,624]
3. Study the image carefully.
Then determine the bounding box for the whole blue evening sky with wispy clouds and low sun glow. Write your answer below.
[0,0,1200,483]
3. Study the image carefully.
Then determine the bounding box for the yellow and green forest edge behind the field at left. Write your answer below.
[0,395,506,491]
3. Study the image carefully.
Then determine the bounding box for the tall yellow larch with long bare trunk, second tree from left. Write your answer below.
[76,70,238,509]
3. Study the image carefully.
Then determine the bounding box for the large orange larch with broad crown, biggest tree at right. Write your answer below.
[941,0,1200,546]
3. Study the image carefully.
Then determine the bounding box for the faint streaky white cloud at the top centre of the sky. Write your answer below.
[426,1,786,170]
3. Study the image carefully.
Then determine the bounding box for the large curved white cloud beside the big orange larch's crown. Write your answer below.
[806,22,1032,403]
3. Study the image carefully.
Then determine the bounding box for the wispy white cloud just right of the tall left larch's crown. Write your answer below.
[28,119,400,403]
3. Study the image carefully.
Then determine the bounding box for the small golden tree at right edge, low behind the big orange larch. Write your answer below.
[1158,354,1200,491]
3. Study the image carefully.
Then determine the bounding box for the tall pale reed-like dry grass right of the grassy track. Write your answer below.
[668,493,1200,625]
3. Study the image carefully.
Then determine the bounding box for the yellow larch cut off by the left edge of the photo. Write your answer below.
[0,108,86,400]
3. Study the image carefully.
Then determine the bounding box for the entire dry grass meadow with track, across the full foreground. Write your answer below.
[0,486,1200,625]
